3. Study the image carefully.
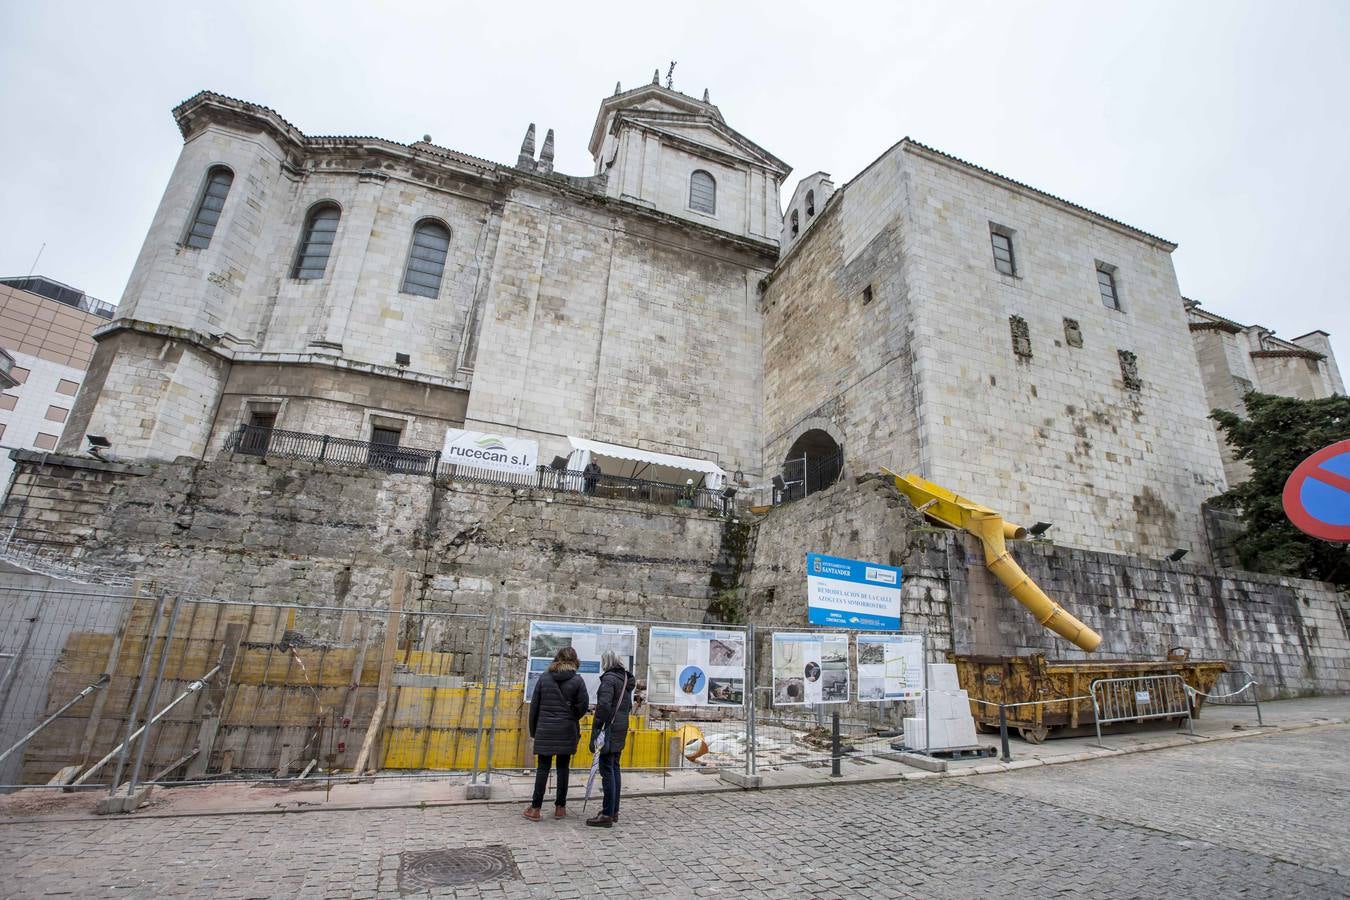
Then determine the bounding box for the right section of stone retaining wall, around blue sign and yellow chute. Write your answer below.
[748,478,1350,698]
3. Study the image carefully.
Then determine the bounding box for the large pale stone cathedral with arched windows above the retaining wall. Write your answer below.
[58,75,1345,560]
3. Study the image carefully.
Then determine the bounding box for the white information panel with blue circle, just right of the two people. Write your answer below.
[647,626,745,706]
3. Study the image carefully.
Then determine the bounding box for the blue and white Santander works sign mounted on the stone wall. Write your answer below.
[806,553,903,631]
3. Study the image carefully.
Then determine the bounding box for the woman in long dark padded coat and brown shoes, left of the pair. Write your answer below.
[524,646,590,822]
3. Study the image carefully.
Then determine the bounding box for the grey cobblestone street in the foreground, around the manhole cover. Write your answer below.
[0,726,1350,897]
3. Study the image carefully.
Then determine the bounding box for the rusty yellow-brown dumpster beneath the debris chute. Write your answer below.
[948,652,1229,743]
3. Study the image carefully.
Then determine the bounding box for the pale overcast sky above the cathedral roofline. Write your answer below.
[0,0,1350,375]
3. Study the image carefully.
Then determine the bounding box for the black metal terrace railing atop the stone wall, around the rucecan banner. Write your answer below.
[225,425,733,515]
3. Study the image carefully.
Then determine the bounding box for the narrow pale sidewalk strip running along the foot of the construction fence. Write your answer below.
[0,696,1350,824]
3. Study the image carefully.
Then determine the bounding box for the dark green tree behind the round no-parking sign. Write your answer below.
[1210,393,1350,587]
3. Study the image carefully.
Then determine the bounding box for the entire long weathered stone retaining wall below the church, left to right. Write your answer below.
[4,453,1350,696]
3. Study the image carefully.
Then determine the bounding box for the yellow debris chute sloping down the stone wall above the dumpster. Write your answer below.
[882,468,1102,653]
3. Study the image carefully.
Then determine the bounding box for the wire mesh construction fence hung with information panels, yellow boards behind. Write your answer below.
[0,572,1242,793]
